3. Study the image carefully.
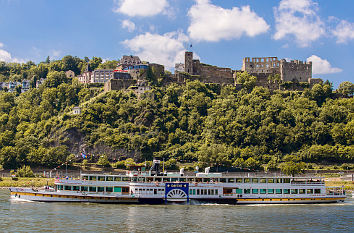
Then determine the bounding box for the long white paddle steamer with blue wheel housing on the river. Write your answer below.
[10,161,345,204]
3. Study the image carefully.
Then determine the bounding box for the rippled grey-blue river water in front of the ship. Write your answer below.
[0,190,354,233]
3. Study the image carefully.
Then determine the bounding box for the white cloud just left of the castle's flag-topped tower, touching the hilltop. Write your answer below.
[123,32,188,69]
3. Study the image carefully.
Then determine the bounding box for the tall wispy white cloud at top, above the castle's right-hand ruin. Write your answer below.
[274,0,325,47]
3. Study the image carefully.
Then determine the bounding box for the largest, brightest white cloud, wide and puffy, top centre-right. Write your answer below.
[188,0,269,41]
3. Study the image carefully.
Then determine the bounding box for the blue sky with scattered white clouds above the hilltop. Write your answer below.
[0,0,354,87]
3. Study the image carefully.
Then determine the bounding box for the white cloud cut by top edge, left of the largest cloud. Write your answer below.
[113,0,168,17]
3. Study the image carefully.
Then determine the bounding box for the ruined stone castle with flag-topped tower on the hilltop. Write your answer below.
[175,51,322,90]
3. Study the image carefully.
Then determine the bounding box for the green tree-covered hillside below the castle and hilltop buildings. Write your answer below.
[0,57,354,169]
